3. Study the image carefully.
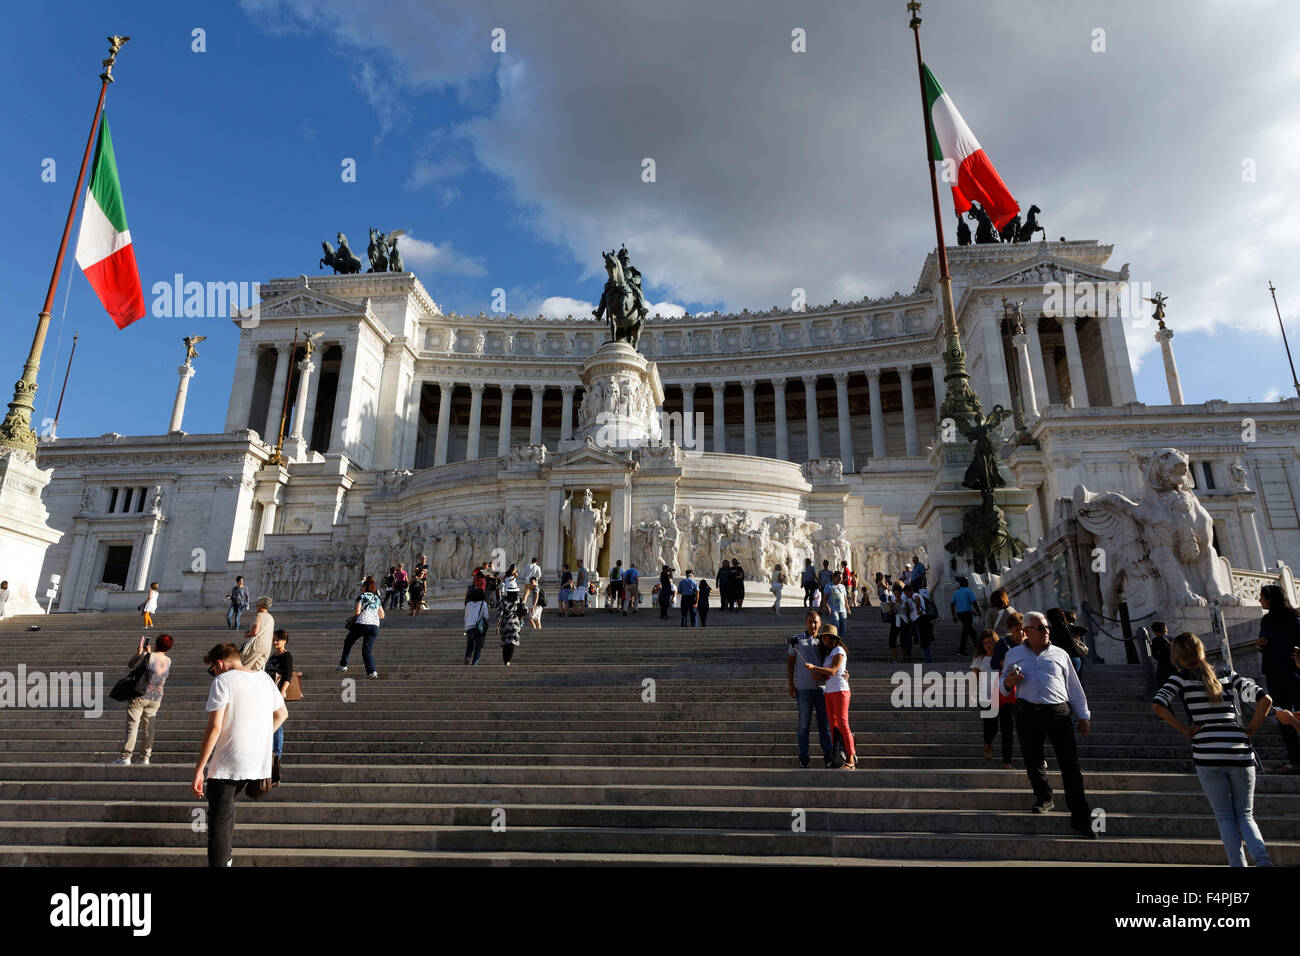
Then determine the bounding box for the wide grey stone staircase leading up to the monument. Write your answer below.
[0,606,1300,866]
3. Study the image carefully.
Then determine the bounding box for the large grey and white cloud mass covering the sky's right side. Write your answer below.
[244,0,1300,385]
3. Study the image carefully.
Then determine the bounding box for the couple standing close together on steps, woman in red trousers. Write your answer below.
[785,610,858,770]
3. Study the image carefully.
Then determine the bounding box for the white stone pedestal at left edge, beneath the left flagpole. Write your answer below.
[0,449,64,614]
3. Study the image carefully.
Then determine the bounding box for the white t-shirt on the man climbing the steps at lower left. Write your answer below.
[207,671,285,780]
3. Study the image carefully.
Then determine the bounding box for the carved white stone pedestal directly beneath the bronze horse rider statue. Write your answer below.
[575,342,663,451]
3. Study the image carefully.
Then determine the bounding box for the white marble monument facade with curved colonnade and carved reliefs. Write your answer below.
[25,241,1300,611]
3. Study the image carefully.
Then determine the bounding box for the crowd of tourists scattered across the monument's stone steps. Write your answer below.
[89,546,1300,866]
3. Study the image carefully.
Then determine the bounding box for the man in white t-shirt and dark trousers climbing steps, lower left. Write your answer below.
[191,643,289,866]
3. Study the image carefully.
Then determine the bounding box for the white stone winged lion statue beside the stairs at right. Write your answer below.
[1074,449,1239,617]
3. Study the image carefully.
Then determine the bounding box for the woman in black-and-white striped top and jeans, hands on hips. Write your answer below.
[1152,632,1273,866]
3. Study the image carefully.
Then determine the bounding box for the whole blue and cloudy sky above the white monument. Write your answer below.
[0,0,1300,436]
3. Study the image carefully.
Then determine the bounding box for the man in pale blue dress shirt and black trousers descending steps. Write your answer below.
[1002,611,1097,839]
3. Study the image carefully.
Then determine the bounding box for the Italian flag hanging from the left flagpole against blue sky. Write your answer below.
[77,117,144,329]
